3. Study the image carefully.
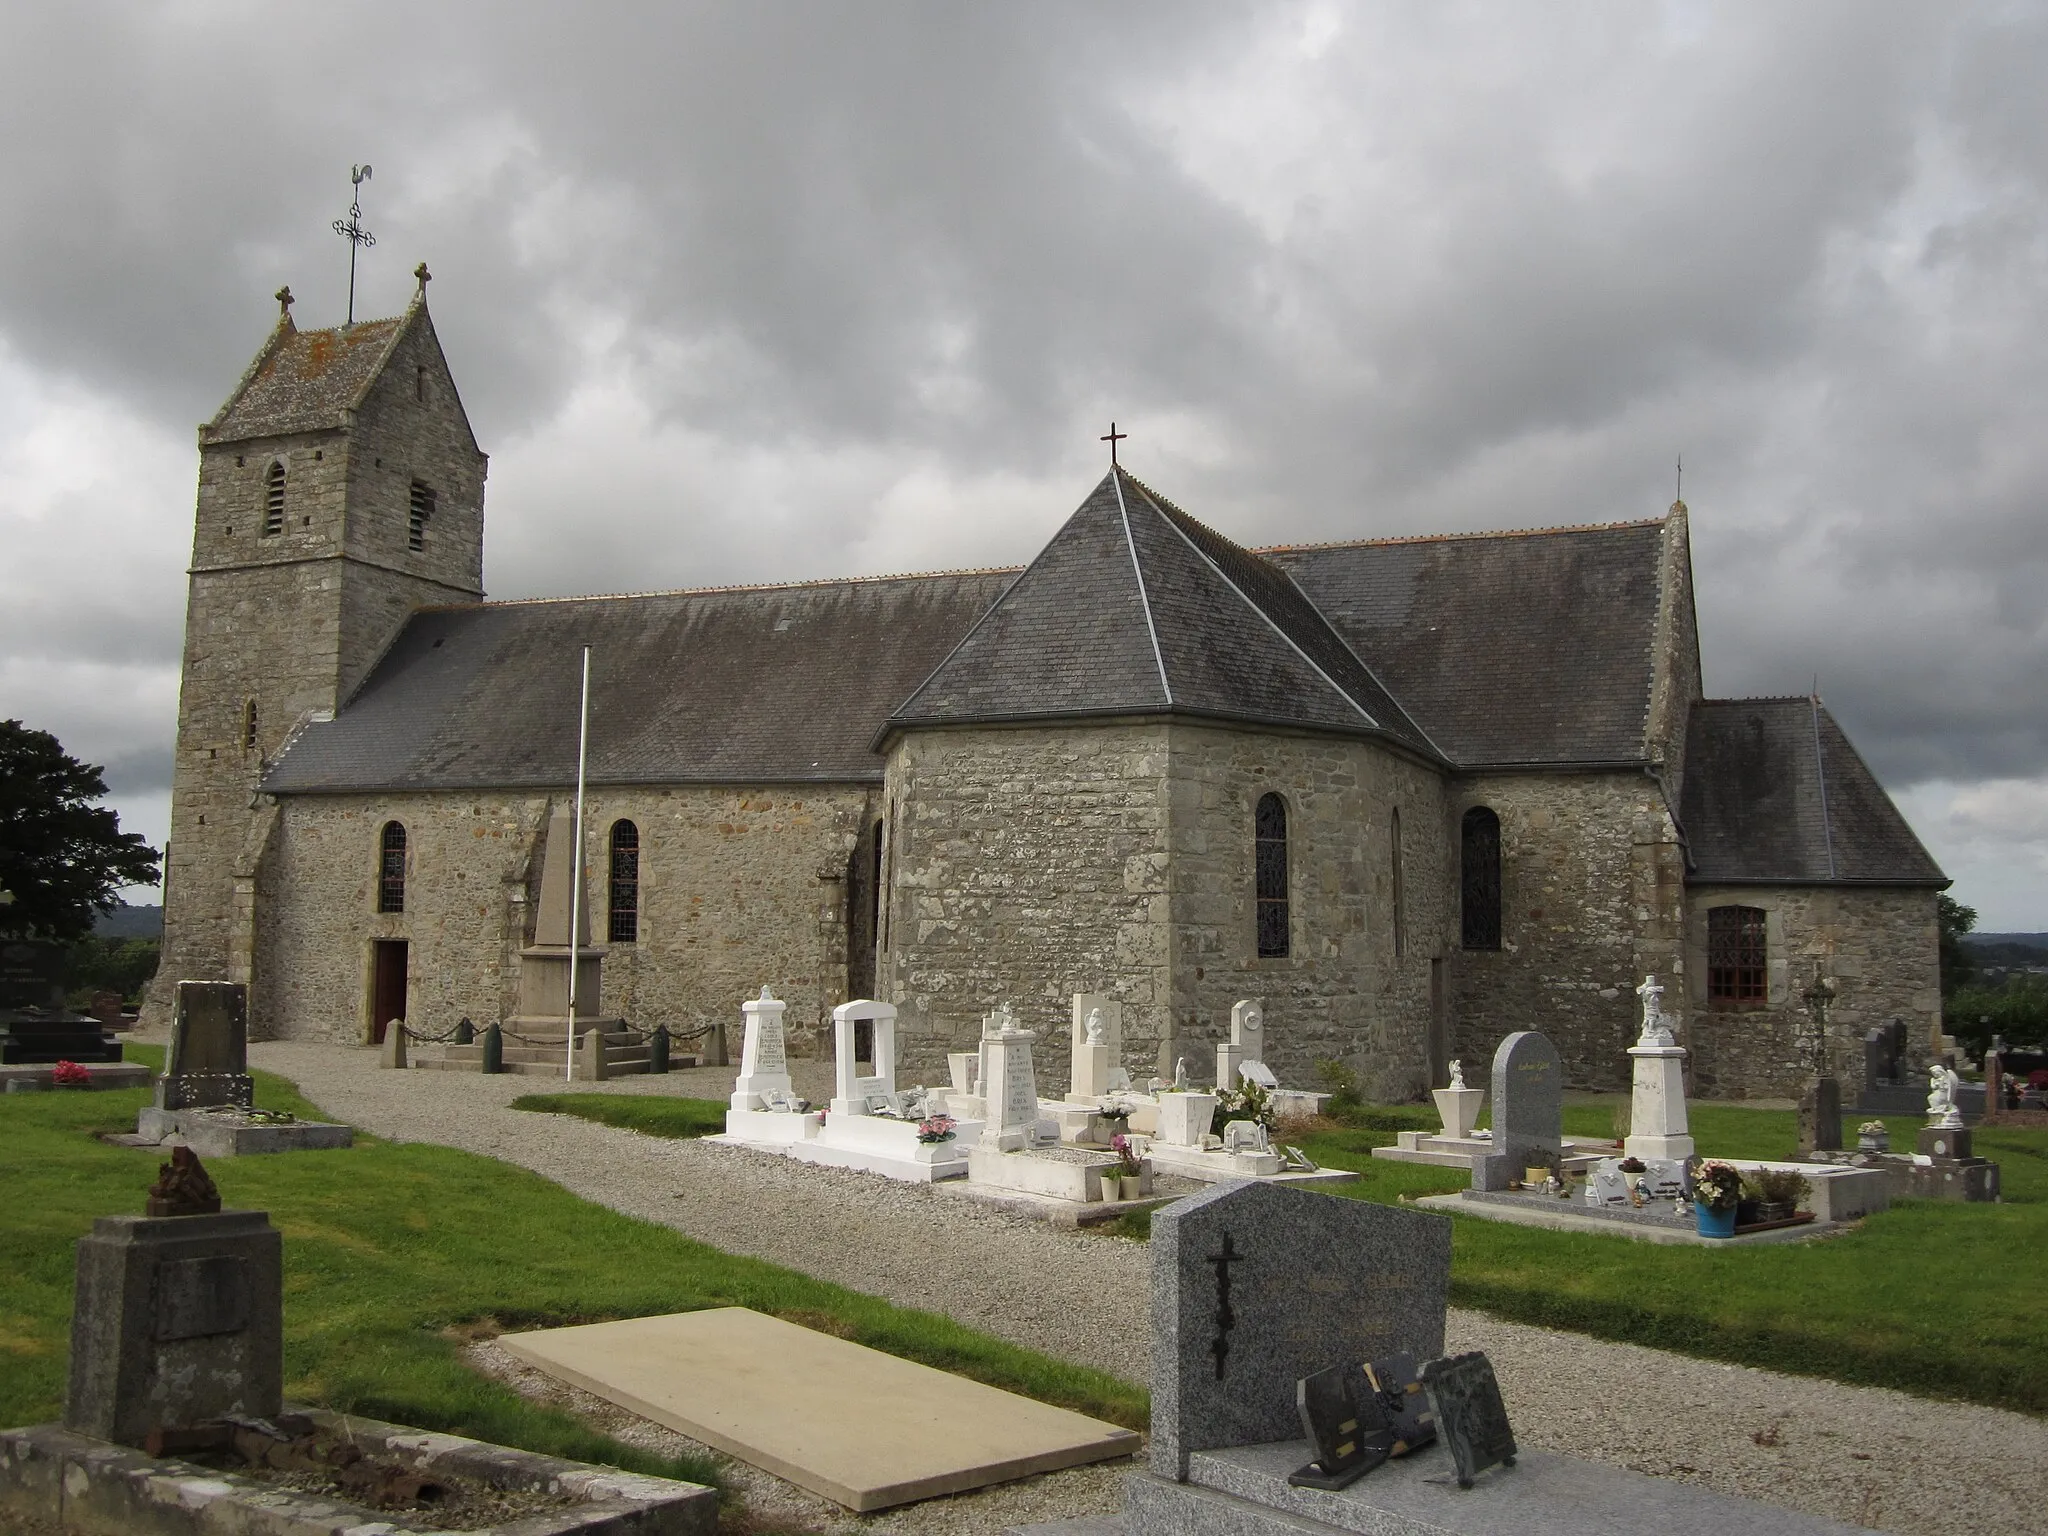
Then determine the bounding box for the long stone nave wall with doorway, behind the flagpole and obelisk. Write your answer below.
[252,784,872,1051]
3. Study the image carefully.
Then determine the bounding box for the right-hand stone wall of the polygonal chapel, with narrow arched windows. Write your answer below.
[1163,723,1450,1100]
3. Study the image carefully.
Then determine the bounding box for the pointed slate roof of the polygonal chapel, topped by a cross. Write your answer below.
[891,469,1440,758]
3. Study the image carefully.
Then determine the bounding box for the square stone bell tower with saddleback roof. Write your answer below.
[150,276,487,1034]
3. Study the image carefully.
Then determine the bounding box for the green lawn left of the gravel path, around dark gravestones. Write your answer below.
[0,1047,1149,1483]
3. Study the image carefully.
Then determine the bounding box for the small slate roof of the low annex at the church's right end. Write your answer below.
[1679,698,1948,885]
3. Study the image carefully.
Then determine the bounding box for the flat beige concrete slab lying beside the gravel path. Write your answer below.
[498,1307,1139,1509]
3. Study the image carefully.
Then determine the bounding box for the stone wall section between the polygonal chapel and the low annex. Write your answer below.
[1444,772,1686,1087]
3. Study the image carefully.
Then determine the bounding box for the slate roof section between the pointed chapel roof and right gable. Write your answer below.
[1260,520,1665,768]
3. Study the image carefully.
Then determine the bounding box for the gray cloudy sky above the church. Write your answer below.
[0,0,2048,930]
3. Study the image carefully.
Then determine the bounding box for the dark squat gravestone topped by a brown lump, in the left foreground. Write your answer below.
[63,1149,285,1448]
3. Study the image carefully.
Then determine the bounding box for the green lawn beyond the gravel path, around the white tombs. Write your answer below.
[491,1094,2048,1413]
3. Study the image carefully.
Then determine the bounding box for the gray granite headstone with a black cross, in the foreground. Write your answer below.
[1151,1184,1450,1481]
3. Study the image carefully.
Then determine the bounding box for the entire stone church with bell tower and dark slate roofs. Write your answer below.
[158,286,1946,1098]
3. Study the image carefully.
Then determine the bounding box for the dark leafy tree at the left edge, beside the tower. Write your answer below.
[0,721,158,940]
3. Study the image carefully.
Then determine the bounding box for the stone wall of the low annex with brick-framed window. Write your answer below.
[1686,885,1942,1102]
